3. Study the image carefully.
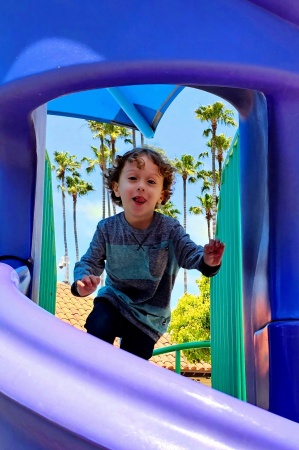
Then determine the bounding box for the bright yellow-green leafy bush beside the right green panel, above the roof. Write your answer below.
[168,276,211,363]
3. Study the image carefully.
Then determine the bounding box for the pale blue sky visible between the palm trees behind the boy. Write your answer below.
[46,88,238,307]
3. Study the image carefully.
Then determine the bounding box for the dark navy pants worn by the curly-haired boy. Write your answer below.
[85,297,155,359]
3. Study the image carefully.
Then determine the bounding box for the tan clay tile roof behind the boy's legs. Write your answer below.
[55,282,211,377]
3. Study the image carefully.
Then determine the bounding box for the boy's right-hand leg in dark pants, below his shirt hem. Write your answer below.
[120,318,156,359]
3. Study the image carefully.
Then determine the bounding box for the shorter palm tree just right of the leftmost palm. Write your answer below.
[66,172,94,261]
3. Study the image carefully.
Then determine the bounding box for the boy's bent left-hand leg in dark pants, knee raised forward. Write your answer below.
[84,297,121,344]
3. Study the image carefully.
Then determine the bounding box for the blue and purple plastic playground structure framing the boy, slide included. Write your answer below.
[0,0,299,450]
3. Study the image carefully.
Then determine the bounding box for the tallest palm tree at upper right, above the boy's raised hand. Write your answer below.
[195,102,237,236]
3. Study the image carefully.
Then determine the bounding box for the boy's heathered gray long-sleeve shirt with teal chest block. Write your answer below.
[72,212,220,340]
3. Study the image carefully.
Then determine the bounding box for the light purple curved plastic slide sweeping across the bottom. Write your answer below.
[0,263,299,450]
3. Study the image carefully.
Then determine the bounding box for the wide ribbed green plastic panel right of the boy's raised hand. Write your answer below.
[211,133,246,401]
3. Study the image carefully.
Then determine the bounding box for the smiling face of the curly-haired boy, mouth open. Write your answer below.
[113,155,164,228]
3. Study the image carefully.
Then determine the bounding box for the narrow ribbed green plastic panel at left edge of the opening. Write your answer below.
[39,155,57,314]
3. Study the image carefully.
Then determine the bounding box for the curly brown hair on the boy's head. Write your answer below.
[105,147,175,206]
